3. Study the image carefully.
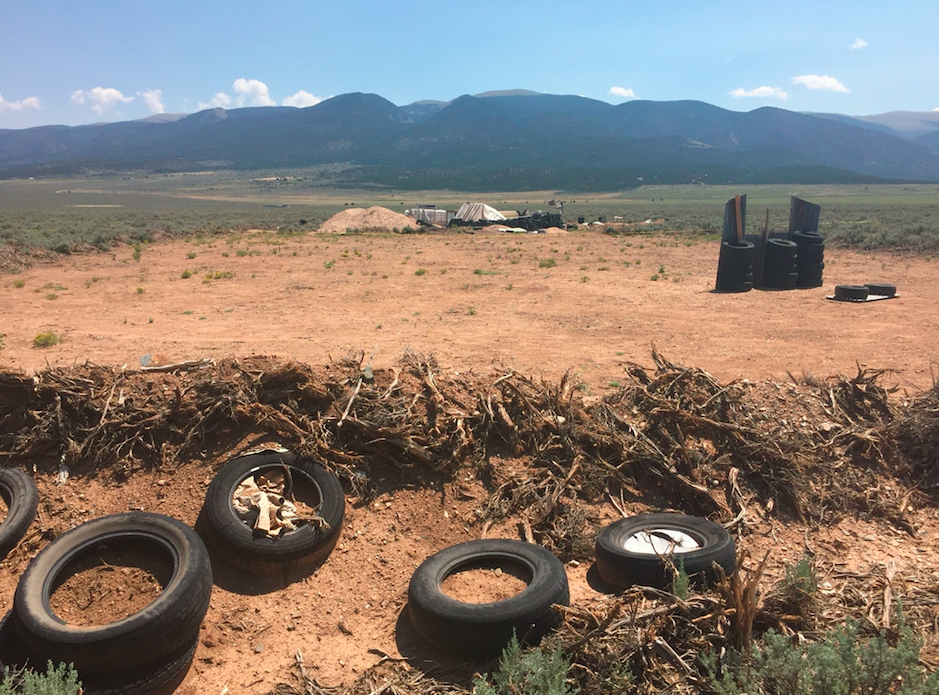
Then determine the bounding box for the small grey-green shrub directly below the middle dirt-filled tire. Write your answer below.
[473,635,579,695]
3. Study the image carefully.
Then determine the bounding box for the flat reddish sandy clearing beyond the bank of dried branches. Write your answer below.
[0,231,939,389]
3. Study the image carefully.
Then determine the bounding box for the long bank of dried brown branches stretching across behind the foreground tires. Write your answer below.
[0,352,939,540]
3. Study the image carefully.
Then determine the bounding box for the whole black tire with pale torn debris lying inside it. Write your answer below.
[200,450,345,574]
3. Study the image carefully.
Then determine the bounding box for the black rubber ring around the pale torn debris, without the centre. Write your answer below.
[202,451,346,574]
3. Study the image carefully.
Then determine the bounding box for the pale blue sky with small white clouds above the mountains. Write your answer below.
[0,0,939,128]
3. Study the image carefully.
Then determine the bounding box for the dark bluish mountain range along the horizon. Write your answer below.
[0,90,939,190]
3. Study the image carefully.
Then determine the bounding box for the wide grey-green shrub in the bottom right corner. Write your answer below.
[705,621,939,695]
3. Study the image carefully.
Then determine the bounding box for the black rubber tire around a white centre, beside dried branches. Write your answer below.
[595,513,737,590]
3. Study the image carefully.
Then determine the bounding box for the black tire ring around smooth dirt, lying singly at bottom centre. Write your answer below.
[408,539,570,656]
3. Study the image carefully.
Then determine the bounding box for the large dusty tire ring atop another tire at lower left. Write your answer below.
[13,512,212,678]
